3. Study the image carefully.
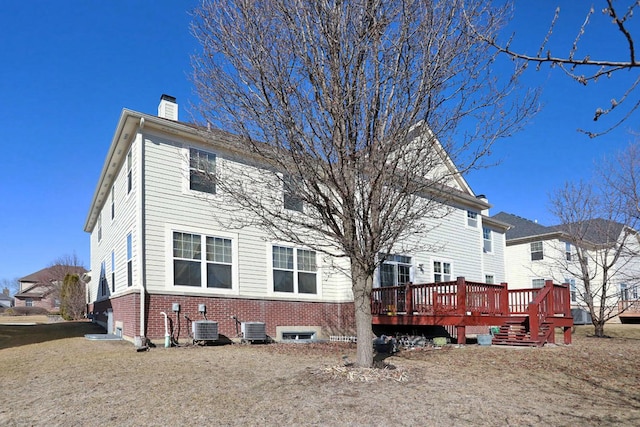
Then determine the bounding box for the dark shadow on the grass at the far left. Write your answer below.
[0,321,105,350]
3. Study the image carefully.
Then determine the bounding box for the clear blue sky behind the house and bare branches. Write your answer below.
[0,0,637,286]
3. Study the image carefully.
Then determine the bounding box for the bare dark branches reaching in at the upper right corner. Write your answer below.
[470,0,640,138]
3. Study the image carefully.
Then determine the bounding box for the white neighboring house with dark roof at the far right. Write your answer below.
[492,212,640,324]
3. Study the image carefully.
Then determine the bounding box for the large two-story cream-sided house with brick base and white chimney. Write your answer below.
[84,95,507,340]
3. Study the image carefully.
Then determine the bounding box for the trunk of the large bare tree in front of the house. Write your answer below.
[351,265,373,368]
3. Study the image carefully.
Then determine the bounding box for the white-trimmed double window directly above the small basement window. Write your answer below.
[271,245,318,294]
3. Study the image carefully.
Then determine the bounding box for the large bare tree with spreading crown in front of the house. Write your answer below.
[193,0,537,366]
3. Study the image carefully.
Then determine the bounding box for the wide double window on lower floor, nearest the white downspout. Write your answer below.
[173,231,233,289]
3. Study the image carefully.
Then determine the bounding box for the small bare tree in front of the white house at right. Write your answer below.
[551,176,640,337]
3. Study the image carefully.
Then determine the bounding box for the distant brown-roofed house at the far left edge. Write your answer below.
[14,265,86,312]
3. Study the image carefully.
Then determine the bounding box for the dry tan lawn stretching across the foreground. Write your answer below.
[0,319,640,426]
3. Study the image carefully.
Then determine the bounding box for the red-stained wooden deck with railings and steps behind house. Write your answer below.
[371,277,573,346]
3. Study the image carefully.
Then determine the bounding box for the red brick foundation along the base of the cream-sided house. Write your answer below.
[89,294,355,341]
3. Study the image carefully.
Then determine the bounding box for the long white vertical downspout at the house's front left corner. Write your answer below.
[136,117,146,341]
